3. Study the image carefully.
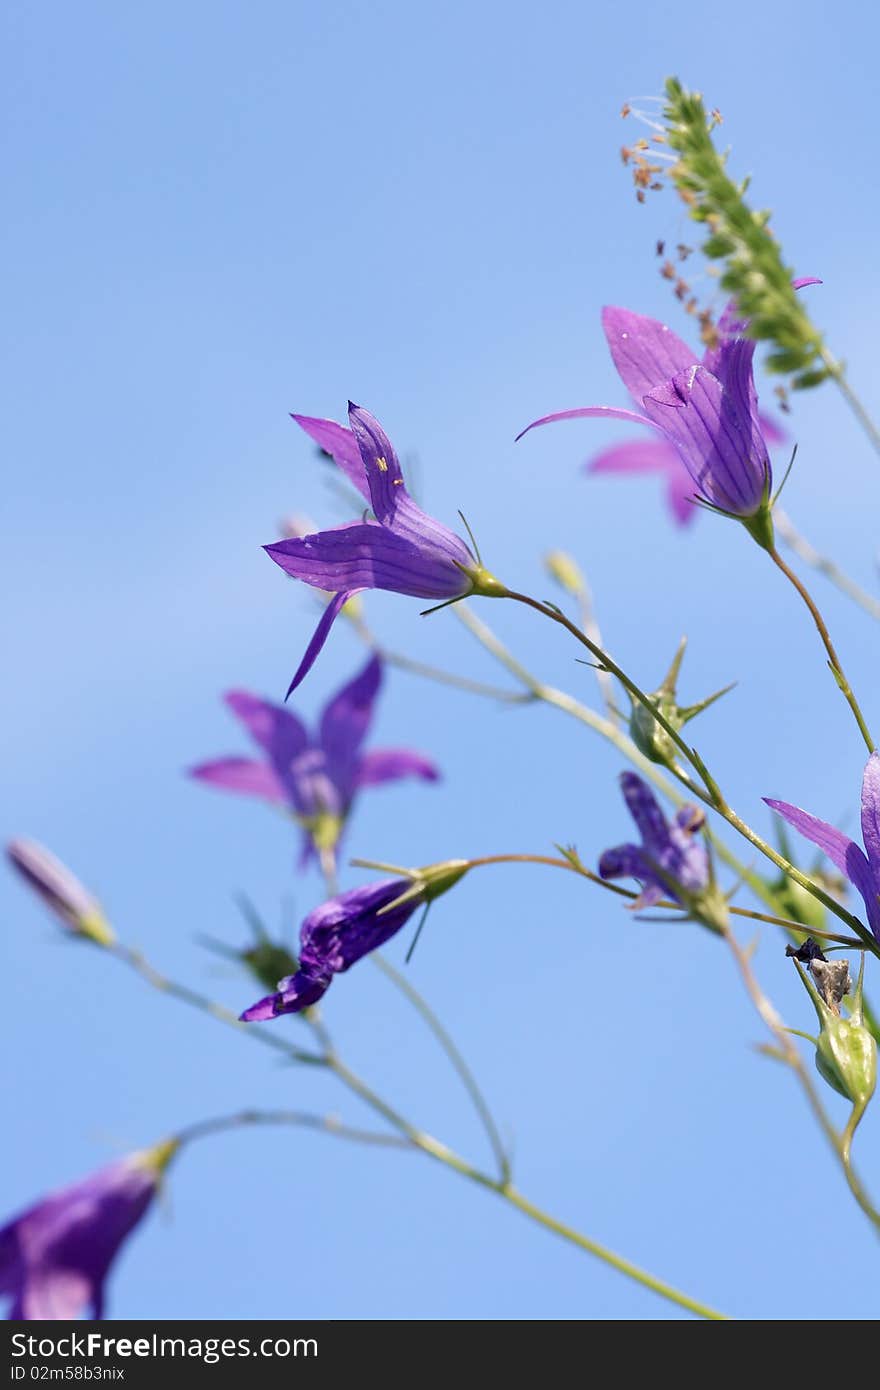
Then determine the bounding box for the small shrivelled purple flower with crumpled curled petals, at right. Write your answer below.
[599,773,709,908]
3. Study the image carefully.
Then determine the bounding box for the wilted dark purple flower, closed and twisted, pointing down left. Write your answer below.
[242,878,425,1023]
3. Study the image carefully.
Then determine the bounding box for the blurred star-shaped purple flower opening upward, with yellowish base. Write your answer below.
[190,656,439,863]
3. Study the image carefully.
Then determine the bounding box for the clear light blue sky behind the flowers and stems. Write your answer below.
[0,0,880,1319]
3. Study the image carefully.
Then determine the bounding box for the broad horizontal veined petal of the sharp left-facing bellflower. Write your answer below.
[264,521,470,599]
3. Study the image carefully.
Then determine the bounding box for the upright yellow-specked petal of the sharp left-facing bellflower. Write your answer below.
[349,402,477,570]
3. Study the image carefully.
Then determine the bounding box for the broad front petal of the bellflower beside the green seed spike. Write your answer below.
[645,367,770,517]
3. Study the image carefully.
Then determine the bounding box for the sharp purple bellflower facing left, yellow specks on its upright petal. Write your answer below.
[266,403,503,695]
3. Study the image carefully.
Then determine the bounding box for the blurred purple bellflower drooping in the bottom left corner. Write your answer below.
[0,1140,178,1322]
